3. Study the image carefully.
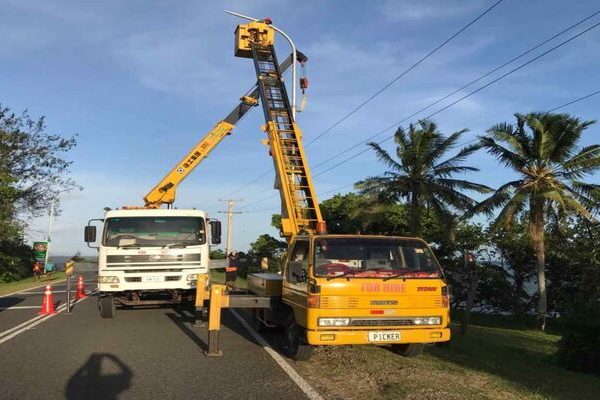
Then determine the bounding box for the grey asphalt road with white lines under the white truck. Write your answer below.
[0,264,316,400]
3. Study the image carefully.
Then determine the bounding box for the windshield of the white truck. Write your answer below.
[103,217,206,247]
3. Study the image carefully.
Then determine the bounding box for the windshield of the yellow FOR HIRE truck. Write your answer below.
[314,237,441,279]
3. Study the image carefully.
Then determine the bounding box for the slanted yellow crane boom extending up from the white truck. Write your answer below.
[144,55,293,208]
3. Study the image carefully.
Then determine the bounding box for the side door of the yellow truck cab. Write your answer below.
[283,239,309,322]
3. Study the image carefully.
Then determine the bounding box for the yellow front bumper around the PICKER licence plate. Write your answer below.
[306,327,450,346]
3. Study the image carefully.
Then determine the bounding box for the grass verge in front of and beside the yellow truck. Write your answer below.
[296,326,600,400]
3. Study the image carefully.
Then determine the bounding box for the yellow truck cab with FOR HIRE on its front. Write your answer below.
[282,235,450,359]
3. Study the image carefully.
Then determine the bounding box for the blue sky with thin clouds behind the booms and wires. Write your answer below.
[0,0,600,254]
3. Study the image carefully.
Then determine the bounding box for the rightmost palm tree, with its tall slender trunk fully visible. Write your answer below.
[473,112,600,330]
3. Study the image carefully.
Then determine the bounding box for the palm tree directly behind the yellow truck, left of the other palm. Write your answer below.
[356,120,492,236]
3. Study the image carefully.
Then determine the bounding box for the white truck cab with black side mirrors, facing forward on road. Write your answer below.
[85,208,221,318]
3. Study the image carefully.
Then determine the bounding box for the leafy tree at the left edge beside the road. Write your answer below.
[0,105,76,282]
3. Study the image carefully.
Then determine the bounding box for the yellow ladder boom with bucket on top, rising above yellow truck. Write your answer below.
[236,21,324,240]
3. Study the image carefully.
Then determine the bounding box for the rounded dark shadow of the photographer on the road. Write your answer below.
[65,353,133,400]
